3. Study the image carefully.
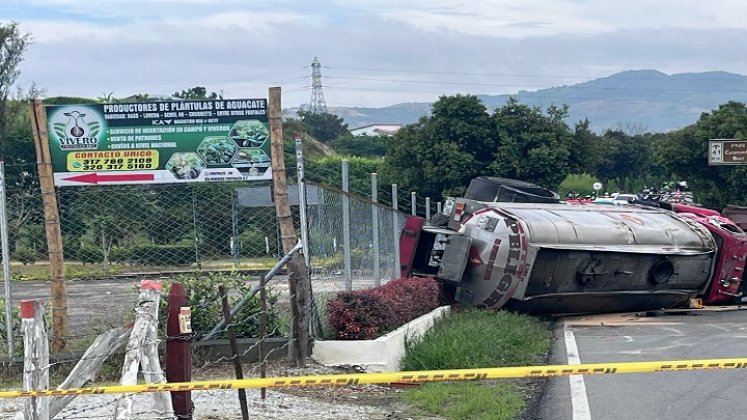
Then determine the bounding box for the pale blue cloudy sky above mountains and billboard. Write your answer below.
[0,0,747,107]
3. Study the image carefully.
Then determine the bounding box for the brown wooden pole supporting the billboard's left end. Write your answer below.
[29,99,67,352]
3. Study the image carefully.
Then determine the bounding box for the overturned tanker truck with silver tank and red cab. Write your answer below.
[400,177,747,313]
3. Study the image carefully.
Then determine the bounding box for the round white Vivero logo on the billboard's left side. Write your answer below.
[52,107,103,150]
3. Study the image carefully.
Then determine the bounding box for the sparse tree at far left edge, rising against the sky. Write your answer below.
[0,22,31,161]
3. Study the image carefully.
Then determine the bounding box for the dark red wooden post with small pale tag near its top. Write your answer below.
[166,282,194,420]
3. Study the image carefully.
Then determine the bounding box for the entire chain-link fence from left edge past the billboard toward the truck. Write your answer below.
[0,162,408,284]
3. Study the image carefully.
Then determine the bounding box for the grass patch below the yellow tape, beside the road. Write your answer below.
[403,382,526,420]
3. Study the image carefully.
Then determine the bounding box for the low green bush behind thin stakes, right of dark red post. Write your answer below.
[159,273,280,339]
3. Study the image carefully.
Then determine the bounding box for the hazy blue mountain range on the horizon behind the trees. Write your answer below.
[312,70,747,132]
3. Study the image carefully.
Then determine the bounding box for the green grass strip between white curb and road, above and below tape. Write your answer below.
[401,309,552,420]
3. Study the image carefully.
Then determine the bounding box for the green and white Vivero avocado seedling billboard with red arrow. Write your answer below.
[46,99,272,186]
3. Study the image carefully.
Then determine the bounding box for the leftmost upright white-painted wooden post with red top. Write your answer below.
[21,300,49,420]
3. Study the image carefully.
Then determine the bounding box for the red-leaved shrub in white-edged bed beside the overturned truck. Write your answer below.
[327,277,439,340]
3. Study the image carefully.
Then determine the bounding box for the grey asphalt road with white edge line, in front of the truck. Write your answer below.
[537,310,747,420]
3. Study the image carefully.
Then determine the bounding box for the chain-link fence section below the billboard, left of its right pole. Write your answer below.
[1,183,280,277]
